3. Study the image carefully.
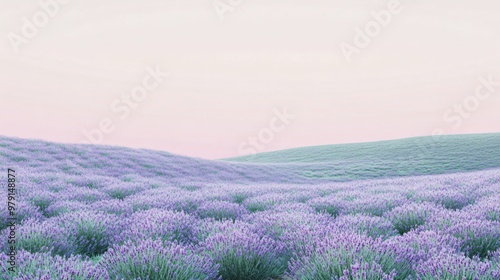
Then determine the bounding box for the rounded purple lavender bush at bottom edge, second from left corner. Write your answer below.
[99,239,218,280]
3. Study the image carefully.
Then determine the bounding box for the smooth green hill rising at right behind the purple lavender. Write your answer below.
[225,133,500,177]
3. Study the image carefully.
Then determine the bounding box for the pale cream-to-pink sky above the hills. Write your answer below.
[0,0,500,158]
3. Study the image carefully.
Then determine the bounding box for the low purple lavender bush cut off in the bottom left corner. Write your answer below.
[0,251,110,280]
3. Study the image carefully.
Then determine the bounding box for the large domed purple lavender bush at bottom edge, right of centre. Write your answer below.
[288,232,413,280]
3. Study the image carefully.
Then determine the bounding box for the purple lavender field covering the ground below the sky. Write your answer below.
[0,135,500,280]
